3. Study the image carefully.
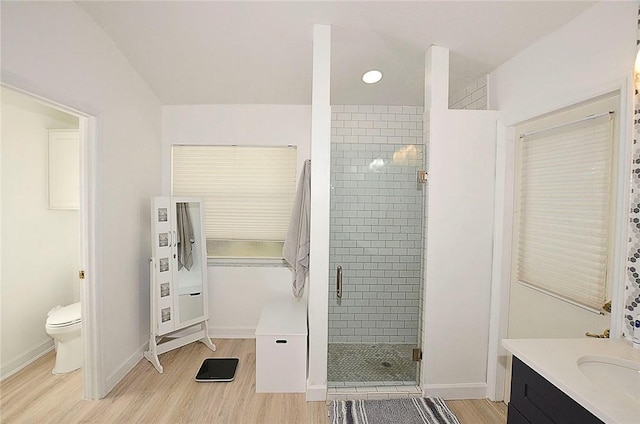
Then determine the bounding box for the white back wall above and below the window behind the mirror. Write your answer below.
[158,105,311,337]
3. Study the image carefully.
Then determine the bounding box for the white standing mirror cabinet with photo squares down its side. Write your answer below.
[145,197,215,372]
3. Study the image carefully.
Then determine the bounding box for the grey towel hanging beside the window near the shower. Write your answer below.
[282,159,311,298]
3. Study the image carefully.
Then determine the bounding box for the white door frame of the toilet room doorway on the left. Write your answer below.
[0,81,105,399]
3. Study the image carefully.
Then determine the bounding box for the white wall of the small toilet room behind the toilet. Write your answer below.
[0,89,80,377]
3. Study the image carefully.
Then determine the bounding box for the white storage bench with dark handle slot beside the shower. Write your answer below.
[256,296,307,393]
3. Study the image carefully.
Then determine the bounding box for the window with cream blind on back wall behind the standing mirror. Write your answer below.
[171,145,296,258]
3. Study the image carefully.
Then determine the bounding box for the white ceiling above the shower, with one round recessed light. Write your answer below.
[78,1,594,105]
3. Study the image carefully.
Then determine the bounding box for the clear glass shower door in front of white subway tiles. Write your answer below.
[327,106,426,387]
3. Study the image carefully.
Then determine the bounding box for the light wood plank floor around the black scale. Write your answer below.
[0,339,506,424]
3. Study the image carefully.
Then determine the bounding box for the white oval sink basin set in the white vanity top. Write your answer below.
[578,355,640,402]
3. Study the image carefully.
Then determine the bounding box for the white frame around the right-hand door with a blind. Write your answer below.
[487,77,633,401]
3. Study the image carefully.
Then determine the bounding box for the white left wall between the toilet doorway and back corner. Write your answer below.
[1,2,161,396]
